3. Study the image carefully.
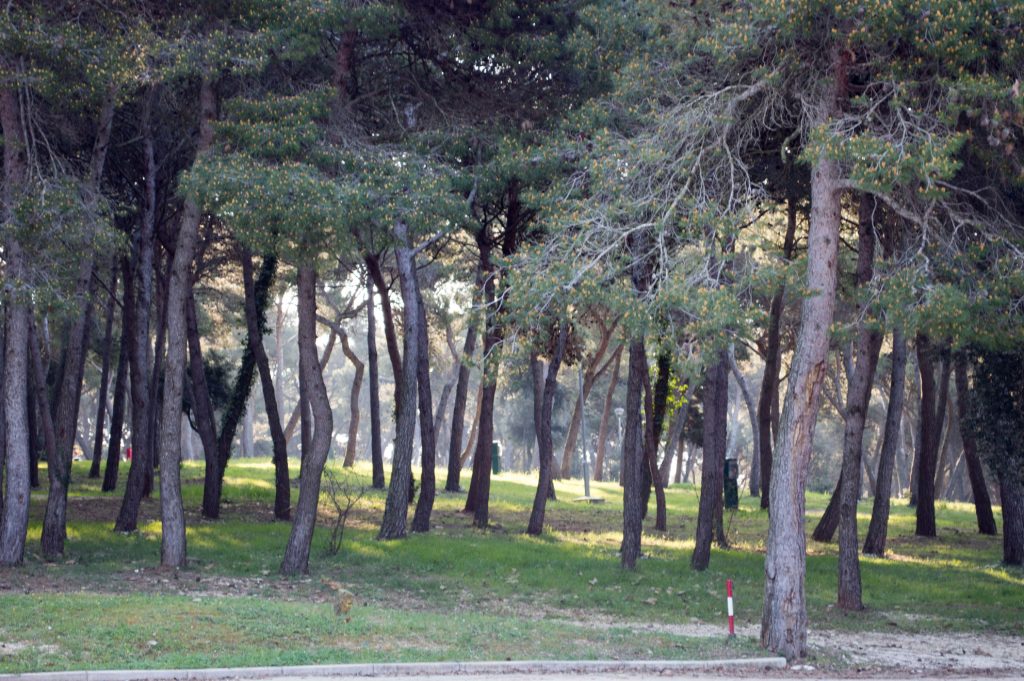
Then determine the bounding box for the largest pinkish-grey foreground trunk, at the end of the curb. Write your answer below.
[761,69,847,659]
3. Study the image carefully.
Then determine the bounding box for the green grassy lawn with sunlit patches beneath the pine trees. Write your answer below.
[0,460,1024,672]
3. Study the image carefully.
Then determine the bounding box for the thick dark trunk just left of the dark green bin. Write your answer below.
[690,351,729,570]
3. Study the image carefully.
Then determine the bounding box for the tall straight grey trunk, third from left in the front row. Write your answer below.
[159,78,217,567]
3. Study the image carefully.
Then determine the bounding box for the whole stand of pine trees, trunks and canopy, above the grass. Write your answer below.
[0,0,1024,661]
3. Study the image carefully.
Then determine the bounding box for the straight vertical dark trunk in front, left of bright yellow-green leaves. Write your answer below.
[622,339,647,569]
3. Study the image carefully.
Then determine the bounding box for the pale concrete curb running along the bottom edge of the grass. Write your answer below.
[0,657,785,681]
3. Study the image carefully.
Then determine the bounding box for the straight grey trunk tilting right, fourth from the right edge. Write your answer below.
[864,326,906,556]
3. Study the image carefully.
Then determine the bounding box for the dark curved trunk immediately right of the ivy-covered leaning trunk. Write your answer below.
[242,253,292,520]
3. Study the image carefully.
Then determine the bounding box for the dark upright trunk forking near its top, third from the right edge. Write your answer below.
[914,334,951,537]
